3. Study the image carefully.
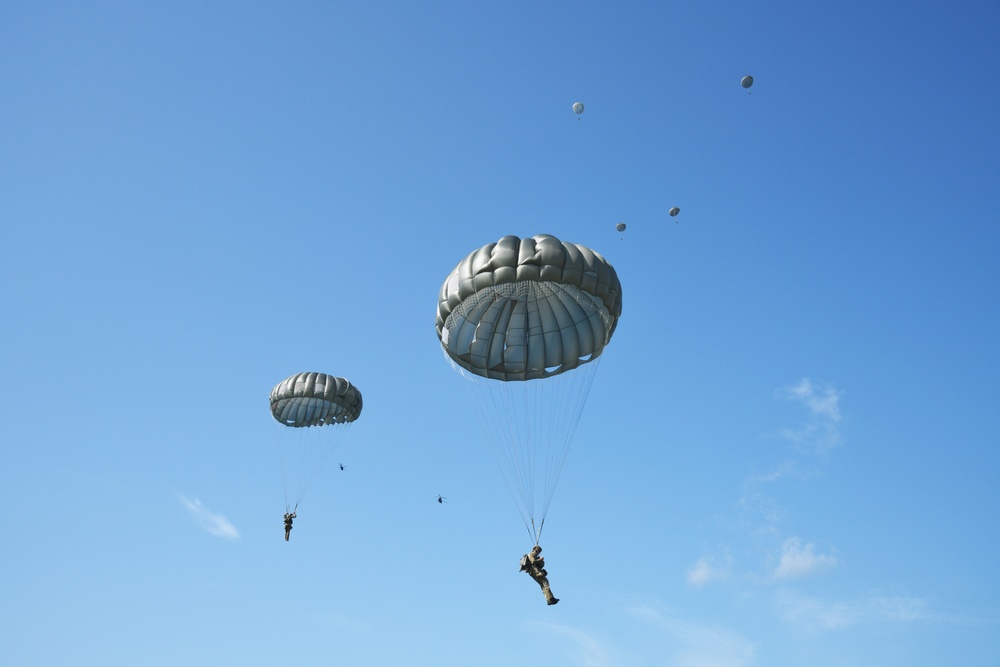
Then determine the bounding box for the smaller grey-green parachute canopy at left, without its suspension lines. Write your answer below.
[271,373,361,428]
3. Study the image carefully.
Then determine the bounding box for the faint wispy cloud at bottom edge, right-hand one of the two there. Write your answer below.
[630,605,757,667]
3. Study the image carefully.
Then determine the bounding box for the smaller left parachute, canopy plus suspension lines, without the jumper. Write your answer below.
[270,373,362,512]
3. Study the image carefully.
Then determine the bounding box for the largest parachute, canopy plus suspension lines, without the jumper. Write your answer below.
[435,234,622,544]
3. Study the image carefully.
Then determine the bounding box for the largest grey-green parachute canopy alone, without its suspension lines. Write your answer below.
[435,234,622,381]
